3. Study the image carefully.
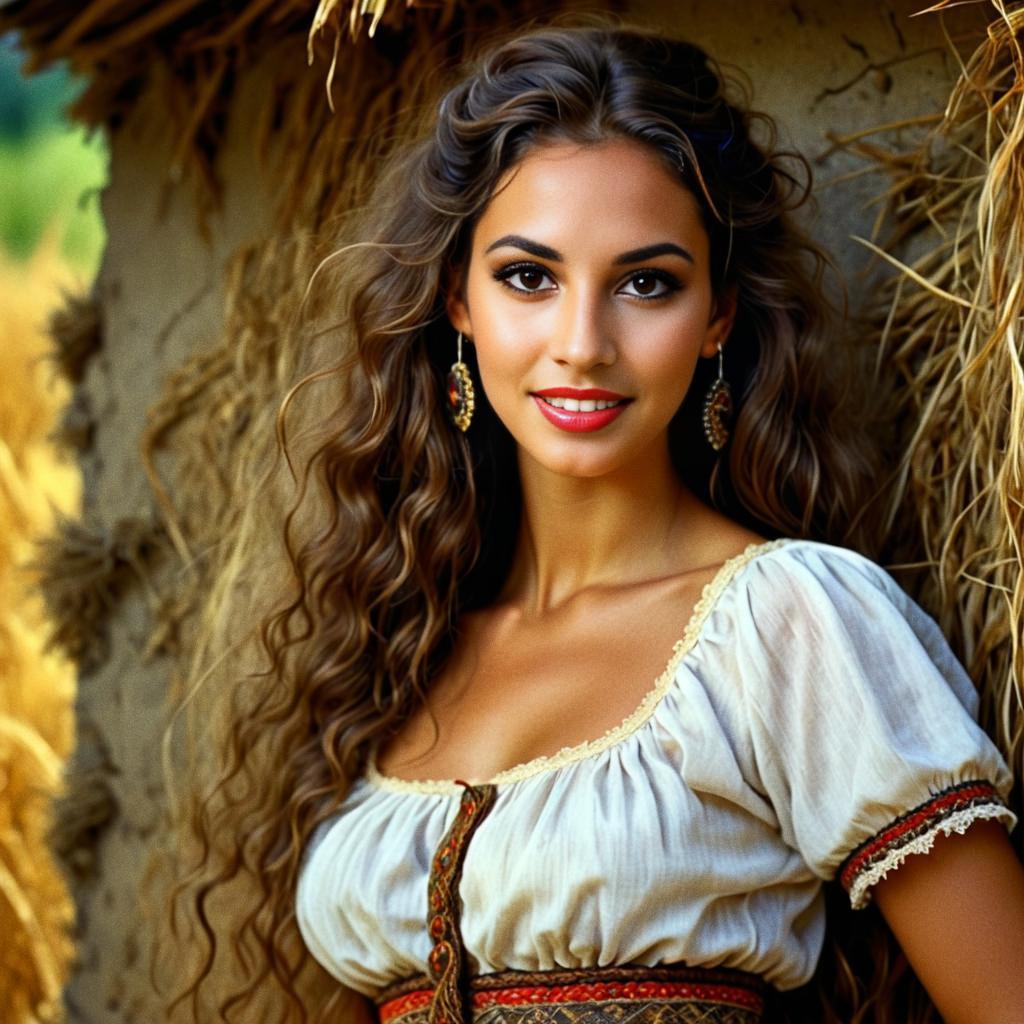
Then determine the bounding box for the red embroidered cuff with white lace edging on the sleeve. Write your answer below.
[838,779,1017,910]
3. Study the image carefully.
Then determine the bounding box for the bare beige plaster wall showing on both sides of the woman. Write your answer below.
[67,0,988,1024]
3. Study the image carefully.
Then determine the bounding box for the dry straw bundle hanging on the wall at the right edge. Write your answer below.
[855,0,1024,806]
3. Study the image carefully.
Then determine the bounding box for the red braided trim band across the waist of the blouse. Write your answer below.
[378,981,764,1024]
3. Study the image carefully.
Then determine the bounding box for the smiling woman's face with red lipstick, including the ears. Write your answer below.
[447,140,733,477]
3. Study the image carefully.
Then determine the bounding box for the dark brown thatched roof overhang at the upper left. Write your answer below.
[0,0,581,226]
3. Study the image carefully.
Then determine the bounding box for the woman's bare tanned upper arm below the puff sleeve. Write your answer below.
[874,821,1024,1024]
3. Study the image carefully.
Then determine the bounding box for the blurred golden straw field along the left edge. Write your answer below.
[0,237,80,1024]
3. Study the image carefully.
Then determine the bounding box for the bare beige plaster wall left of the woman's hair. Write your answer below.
[66,54,272,1024]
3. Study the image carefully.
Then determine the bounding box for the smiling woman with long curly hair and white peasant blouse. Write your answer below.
[174,18,1024,1024]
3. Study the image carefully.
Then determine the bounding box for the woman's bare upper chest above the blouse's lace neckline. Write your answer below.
[377,578,706,780]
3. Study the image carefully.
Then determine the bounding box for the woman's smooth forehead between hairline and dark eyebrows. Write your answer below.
[474,139,708,255]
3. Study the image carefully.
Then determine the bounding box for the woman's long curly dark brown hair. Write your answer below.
[161,22,913,1022]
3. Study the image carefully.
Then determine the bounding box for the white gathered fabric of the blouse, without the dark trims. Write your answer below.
[296,540,1016,996]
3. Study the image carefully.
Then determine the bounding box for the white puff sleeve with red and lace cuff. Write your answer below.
[734,542,1017,908]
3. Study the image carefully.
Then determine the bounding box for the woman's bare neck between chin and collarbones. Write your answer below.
[502,446,701,615]
